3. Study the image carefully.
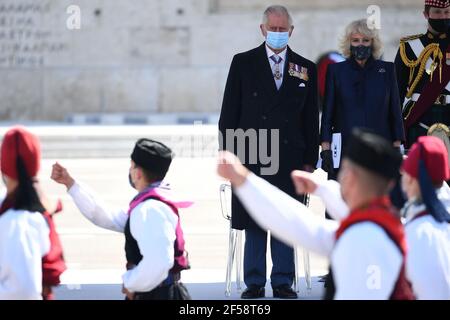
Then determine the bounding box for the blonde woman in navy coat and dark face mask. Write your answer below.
[321,19,404,175]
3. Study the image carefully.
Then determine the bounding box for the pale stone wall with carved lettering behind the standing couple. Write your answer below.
[0,0,426,121]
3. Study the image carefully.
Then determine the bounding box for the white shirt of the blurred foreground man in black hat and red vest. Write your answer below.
[235,174,403,299]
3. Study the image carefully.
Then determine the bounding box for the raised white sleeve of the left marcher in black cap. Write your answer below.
[68,182,128,232]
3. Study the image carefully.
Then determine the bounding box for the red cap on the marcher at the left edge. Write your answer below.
[0,126,41,180]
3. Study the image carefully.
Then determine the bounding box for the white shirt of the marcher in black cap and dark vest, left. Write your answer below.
[68,183,178,292]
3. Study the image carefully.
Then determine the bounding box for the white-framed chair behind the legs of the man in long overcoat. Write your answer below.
[220,183,312,297]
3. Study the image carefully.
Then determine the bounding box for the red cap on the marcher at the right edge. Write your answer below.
[402,136,450,184]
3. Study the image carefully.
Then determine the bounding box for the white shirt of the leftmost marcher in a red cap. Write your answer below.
[0,205,50,300]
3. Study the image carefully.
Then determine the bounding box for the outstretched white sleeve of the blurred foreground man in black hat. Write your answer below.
[235,173,338,256]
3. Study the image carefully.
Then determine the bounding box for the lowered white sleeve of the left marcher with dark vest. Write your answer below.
[122,200,178,292]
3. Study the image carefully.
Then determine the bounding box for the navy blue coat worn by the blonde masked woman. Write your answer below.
[321,59,405,148]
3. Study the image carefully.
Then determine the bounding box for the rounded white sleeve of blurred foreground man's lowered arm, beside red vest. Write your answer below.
[331,222,403,300]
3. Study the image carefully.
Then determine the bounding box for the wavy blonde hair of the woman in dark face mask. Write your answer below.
[339,19,383,59]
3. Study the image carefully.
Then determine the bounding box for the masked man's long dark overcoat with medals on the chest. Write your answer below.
[219,43,319,229]
